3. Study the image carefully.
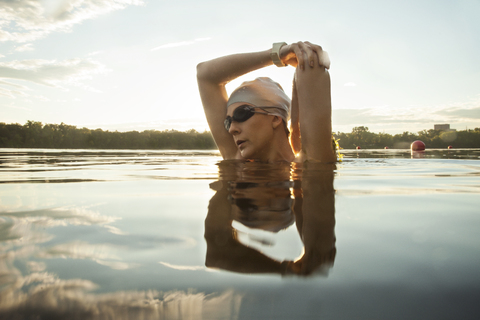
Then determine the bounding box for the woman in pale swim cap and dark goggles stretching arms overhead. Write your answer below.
[197,42,336,163]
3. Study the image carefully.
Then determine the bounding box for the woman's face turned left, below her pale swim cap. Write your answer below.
[227,102,274,160]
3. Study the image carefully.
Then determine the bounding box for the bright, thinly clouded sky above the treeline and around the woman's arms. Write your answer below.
[0,0,480,134]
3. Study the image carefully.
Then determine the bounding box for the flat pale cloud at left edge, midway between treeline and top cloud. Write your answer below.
[0,57,108,97]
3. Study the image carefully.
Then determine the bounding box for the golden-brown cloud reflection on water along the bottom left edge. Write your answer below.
[0,272,243,320]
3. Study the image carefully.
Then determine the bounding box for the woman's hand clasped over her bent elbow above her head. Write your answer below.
[280,41,330,70]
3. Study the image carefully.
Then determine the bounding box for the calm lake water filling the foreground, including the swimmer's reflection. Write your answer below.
[0,149,480,320]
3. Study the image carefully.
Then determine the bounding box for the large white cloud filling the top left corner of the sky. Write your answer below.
[0,0,144,42]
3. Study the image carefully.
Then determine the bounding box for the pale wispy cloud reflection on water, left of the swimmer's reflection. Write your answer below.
[0,207,195,278]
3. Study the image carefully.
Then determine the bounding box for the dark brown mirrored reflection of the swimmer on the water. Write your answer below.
[205,161,336,275]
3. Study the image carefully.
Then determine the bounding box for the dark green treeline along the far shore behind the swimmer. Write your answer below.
[0,121,480,149]
